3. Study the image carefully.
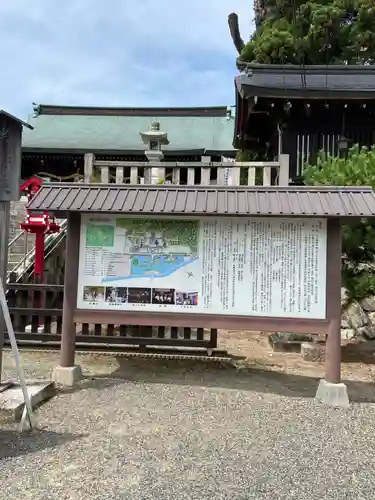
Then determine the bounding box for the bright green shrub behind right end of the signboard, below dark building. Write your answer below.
[304,145,375,300]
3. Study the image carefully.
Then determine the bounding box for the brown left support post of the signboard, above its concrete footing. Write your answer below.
[60,212,81,367]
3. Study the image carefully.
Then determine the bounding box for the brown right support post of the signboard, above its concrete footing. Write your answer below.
[325,219,342,384]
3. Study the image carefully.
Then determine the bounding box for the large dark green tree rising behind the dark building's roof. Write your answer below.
[239,0,375,65]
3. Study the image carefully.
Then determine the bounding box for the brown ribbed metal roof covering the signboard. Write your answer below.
[28,183,375,217]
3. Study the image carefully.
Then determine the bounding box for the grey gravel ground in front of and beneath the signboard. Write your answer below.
[0,350,375,500]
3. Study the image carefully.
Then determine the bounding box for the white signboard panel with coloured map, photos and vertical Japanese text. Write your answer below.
[77,215,326,318]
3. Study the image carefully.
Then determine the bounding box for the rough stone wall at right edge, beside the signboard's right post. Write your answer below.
[341,288,375,340]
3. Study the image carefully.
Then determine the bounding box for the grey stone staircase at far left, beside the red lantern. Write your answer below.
[8,199,35,272]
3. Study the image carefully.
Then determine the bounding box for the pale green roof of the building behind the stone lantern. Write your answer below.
[22,106,234,152]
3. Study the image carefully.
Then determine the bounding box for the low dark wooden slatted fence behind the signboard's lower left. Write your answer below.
[7,283,217,349]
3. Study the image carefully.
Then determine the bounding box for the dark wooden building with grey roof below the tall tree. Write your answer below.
[234,64,375,179]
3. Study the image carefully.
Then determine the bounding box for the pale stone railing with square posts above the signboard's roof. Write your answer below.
[84,153,289,186]
